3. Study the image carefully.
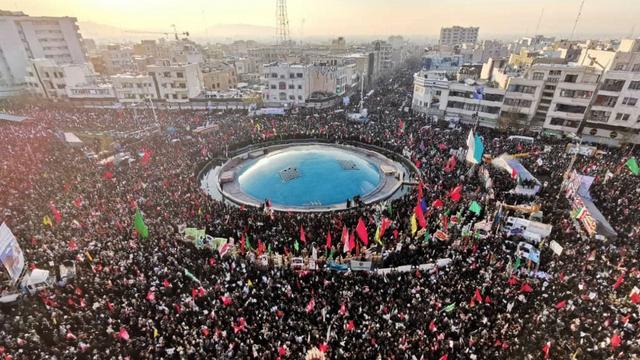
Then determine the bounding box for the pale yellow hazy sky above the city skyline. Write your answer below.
[0,0,640,38]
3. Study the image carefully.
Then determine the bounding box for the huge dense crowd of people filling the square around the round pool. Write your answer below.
[0,65,640,360]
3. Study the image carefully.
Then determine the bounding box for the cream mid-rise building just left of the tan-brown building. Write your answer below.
[147,64,204,102]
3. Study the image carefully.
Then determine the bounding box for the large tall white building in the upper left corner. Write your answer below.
[0,10,87,97]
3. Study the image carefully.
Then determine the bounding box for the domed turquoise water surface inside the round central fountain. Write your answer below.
[238,145,382,206]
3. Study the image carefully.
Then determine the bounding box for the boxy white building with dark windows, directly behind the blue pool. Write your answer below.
[262,62,313,106]
